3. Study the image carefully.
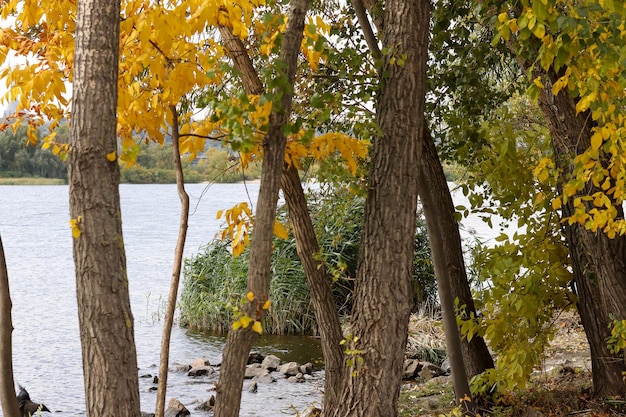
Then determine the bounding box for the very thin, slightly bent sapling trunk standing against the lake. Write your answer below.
[155,104,189,417]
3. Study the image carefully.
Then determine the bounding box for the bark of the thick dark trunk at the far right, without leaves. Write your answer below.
[535,66,626,397]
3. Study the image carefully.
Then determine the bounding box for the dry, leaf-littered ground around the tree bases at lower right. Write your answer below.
[399,313,626,417]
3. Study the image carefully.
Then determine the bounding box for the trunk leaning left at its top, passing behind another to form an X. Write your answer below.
[220,27,344,409]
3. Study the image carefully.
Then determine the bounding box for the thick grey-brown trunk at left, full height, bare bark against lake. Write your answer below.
[68,0,140,417]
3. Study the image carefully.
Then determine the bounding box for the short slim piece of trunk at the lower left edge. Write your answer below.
[0,238,21,417]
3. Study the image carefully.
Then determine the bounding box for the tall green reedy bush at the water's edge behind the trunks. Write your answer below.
[180,185,436,334]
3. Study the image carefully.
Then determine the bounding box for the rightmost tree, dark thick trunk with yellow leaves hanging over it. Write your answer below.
[486,0,626,396]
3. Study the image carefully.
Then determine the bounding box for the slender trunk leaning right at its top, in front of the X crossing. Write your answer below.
[215,0,308,417]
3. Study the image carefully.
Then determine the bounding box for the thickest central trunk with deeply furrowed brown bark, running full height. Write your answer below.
[328,0,430,417]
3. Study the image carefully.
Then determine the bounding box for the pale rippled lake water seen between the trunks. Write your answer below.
[0,184,321,417]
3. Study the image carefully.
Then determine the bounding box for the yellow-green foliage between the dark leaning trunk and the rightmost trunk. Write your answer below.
[458,97,575,391]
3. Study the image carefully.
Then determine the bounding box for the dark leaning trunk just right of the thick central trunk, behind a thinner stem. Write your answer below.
[420,129,494,379]
